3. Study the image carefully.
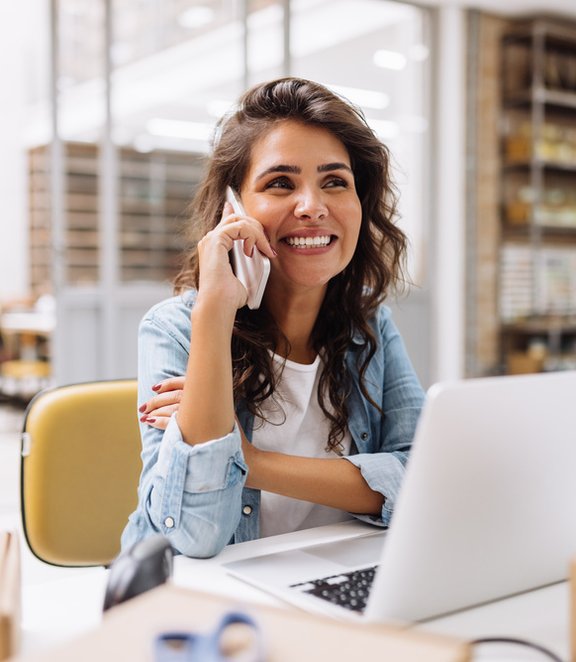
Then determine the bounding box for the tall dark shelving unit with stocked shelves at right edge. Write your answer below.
[498,19,576,373]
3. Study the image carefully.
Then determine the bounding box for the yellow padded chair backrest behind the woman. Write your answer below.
[20,380,141,566]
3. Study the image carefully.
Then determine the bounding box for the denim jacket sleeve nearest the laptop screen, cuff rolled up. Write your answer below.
[345,308,424,526]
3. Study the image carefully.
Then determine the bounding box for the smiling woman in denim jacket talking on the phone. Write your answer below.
[122,78,423,557]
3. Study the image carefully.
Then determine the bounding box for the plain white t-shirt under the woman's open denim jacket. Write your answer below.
[252,355,351,537]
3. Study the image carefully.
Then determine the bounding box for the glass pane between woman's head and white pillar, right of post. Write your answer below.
[291,0,430,285]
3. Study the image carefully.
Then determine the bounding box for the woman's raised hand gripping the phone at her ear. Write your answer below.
[197,202,275,310]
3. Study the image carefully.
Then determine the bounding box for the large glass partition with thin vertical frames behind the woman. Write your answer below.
[28,0,430,381]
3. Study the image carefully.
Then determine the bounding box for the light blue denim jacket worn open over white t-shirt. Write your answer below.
[122,290,424,557]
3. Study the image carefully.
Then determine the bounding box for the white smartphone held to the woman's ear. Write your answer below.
[226,186,270,310]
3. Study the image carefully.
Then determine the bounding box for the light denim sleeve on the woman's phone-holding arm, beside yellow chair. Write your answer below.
[122,305,247,557]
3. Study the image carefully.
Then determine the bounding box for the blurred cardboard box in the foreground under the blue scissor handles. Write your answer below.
[12,585,470,662]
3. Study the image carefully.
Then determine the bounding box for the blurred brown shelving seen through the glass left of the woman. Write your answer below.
[29,143,203,295]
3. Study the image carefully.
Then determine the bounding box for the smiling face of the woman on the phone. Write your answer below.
[240,120,362,292]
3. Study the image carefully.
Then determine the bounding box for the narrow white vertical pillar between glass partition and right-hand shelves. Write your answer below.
[431,5,466,382]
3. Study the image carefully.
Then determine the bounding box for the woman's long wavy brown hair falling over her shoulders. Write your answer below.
[174,78,407,450]
